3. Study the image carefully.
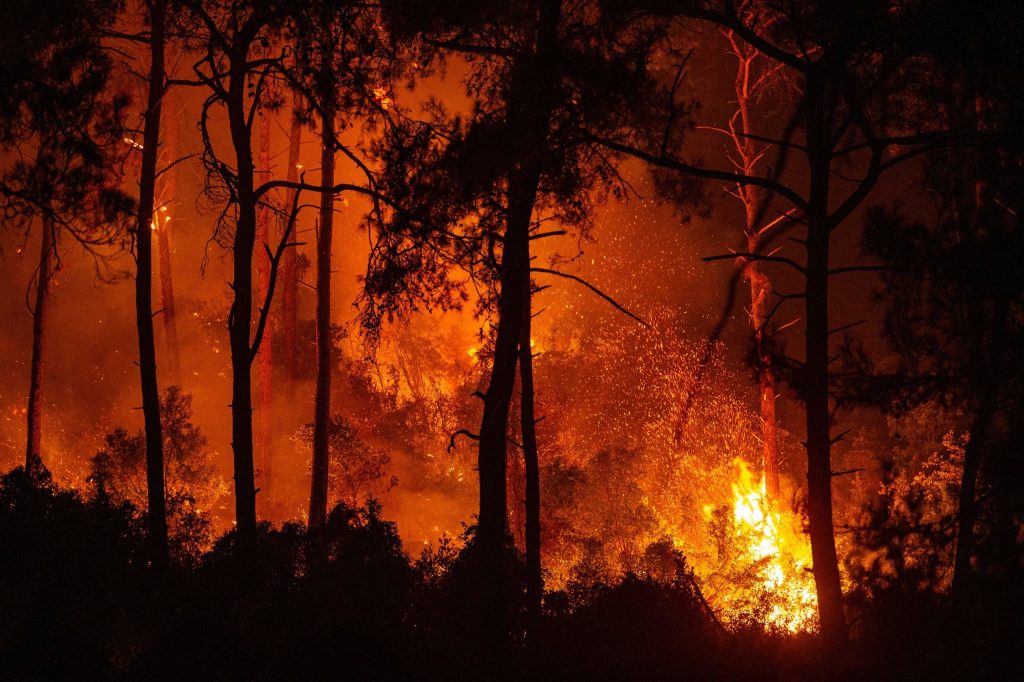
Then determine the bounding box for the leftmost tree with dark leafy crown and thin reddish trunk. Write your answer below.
[0,2,130,472]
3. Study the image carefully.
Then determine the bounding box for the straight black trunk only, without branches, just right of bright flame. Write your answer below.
[804,74,847,646]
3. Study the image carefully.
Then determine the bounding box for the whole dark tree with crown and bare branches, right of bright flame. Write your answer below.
[601,2,987,644]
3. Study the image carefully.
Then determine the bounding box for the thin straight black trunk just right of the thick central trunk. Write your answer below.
[519,284,544,623]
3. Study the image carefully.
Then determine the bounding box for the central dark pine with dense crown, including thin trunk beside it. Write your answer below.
[382,1,663,630]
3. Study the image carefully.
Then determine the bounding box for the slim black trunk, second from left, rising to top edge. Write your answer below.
[135,0,168,564]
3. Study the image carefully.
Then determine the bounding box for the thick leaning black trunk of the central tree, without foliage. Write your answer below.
[476,0,561,646]
